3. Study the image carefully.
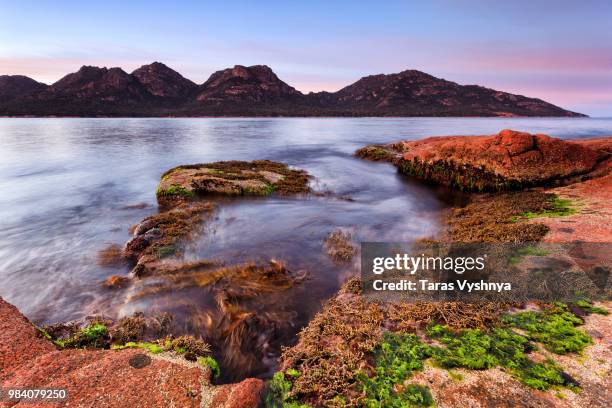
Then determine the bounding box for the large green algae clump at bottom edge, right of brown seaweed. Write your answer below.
[357,332,433,407]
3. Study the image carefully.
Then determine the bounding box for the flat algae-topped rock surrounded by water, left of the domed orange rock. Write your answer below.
[157,160,310,204]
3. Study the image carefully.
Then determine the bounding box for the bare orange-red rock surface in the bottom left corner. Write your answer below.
[0,298,264,408]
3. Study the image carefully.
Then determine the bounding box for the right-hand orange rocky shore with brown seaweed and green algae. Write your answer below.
[278,130,612,407]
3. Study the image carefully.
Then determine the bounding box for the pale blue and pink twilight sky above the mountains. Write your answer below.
[0,0,612,117]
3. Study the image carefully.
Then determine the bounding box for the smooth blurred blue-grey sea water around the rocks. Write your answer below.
[0,118,612,380]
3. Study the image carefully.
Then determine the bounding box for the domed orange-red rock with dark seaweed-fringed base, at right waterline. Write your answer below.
[357,129,605,191]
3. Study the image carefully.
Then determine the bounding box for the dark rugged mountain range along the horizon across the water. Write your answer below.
[0,62,585,117]
